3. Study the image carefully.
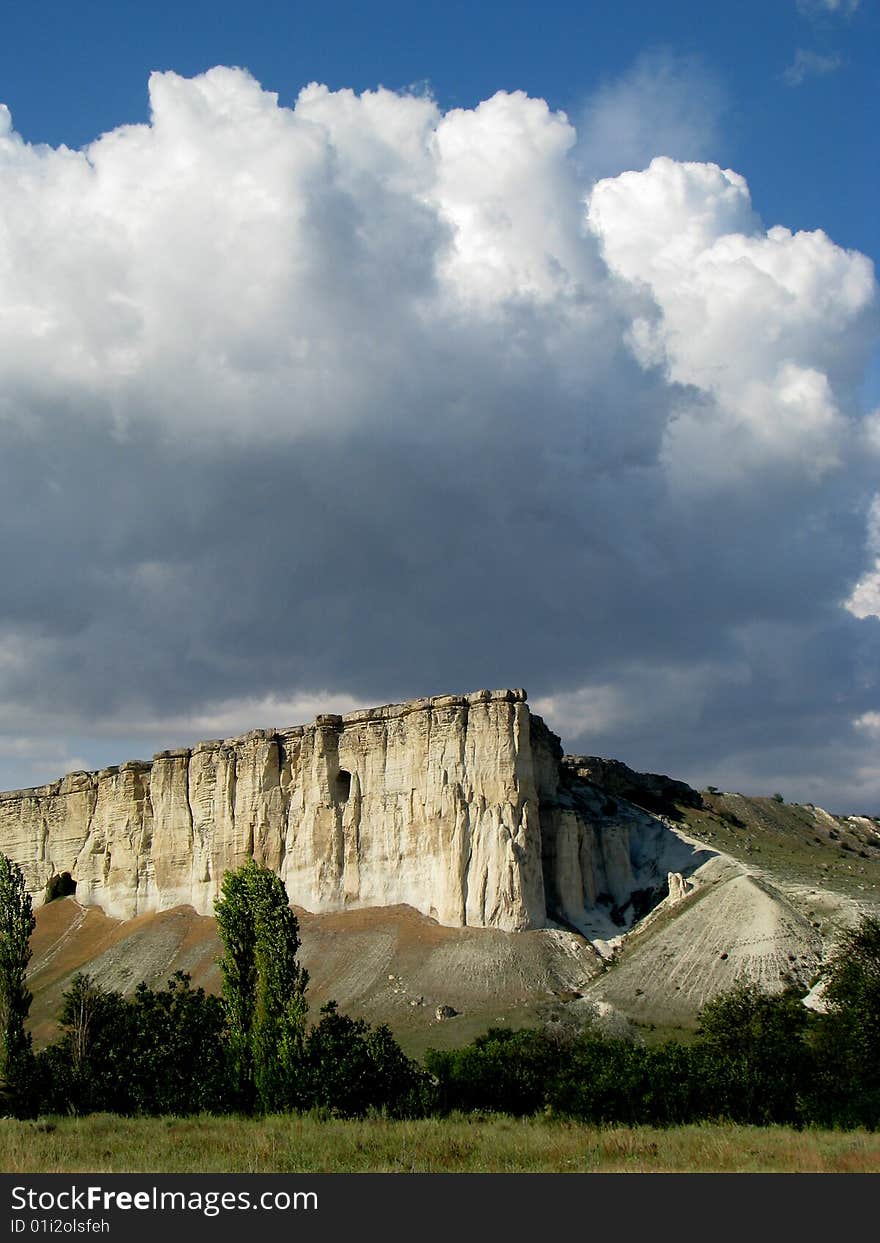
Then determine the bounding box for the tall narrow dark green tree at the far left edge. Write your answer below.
[0,855,35,1114]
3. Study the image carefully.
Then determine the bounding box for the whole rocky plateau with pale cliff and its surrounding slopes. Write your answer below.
[0,690,880,1048]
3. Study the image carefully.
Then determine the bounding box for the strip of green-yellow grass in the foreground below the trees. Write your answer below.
[0,1114,880,1173]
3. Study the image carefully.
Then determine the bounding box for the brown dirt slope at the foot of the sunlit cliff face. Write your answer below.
[29,897,600,1052]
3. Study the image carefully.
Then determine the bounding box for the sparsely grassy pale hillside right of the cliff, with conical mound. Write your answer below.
[564,791,880,1042]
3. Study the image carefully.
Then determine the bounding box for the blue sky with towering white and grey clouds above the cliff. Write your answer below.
[0,0,880,814]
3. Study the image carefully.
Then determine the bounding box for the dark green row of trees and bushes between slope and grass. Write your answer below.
[0,855,880,1129]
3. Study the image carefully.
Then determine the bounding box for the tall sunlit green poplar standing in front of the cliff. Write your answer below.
[214,859,308,1112]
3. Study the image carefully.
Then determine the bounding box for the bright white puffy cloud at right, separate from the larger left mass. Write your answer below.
[589,158,875,486]
